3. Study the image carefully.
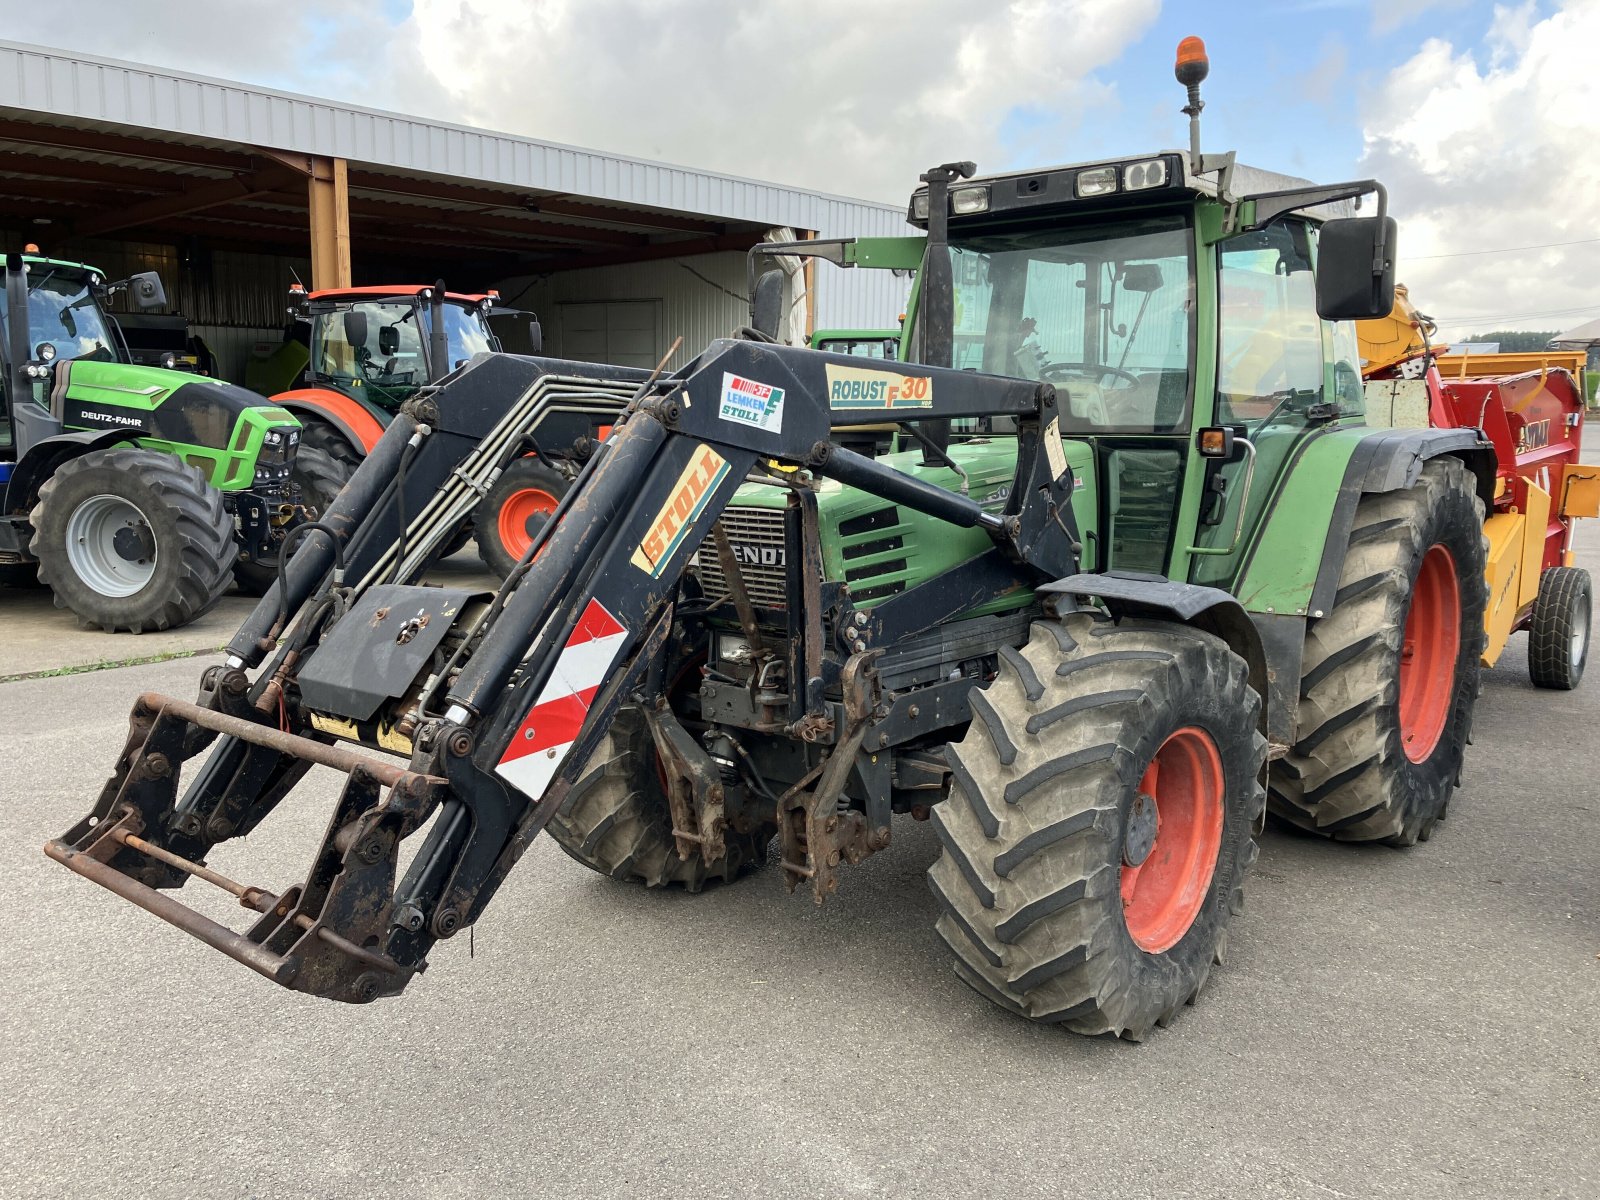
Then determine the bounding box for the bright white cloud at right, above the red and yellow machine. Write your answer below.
[1363,0,1600,338]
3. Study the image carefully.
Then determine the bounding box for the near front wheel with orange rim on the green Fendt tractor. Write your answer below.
[928,613,1267,1040]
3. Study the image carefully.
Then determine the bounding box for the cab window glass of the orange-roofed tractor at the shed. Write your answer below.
[312,301,493,400]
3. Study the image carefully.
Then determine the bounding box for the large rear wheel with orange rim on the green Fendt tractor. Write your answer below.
[1270,458,1488,846]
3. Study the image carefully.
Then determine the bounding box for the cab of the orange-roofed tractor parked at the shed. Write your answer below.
[291,285,501,413]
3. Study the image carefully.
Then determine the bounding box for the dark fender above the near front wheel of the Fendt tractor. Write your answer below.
[1038,571,1273,741]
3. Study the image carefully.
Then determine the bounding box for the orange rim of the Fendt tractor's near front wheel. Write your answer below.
[1122,725,1226,954]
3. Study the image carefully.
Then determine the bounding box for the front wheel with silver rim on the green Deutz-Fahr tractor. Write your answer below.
[29,448,235,634]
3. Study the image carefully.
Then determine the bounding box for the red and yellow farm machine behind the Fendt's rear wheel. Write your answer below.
[1358,286,1600,690]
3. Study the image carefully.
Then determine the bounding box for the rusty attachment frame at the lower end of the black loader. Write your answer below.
[45,693,448,1003]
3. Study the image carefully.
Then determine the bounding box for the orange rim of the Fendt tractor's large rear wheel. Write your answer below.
[1400,544,1461,763]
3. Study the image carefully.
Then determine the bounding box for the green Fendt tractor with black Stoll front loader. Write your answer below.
[46,40,1494,1038]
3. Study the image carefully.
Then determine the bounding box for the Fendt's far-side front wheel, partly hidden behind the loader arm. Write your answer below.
[547,707,778,891]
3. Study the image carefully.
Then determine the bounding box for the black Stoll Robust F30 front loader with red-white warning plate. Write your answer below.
[46,341,1077,1002]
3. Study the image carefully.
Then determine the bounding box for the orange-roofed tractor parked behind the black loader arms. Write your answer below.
[272,280,614,578]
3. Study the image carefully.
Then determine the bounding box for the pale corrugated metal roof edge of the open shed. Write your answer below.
[0,42,901,234]
